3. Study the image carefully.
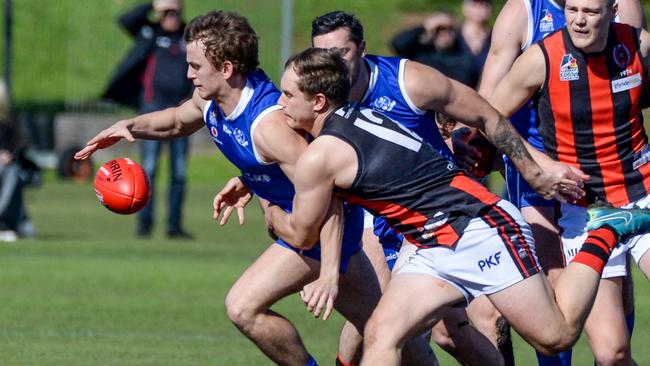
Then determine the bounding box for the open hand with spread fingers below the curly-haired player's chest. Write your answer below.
[212,177,253,226]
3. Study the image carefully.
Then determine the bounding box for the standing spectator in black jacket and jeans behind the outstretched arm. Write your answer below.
[104,0,192,239]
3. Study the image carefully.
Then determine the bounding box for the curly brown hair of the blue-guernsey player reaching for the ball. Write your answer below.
[183,11,259,74]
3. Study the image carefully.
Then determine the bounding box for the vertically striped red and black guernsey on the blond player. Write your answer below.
[538,23,650,206]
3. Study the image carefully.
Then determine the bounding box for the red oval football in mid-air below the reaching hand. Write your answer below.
[95,158,151,215]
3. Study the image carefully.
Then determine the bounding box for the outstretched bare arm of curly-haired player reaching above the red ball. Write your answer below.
[75,92,206,159]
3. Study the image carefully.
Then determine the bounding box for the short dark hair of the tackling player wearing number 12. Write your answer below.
[284,48,350,107]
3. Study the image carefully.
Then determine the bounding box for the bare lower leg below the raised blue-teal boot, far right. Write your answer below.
[585,277,632,365]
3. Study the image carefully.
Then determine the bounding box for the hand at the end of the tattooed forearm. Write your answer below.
[529,159,589,203]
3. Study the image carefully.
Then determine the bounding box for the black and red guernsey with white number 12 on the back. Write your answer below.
[321,104,499,247]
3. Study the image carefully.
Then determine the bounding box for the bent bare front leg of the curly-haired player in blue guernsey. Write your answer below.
[226,244,320,366]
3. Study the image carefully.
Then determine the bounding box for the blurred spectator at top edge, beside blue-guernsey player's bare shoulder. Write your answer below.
[460,0,492,74]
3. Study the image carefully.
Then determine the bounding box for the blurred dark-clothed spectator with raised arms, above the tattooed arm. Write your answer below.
[391,10,479,88]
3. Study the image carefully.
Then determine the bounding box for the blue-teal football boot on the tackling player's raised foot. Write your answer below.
[587,206,650,243]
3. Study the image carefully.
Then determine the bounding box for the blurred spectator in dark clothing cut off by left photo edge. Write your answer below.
[0,81,40,242]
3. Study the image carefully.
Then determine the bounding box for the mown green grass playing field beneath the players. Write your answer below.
[0,155,650,366]
